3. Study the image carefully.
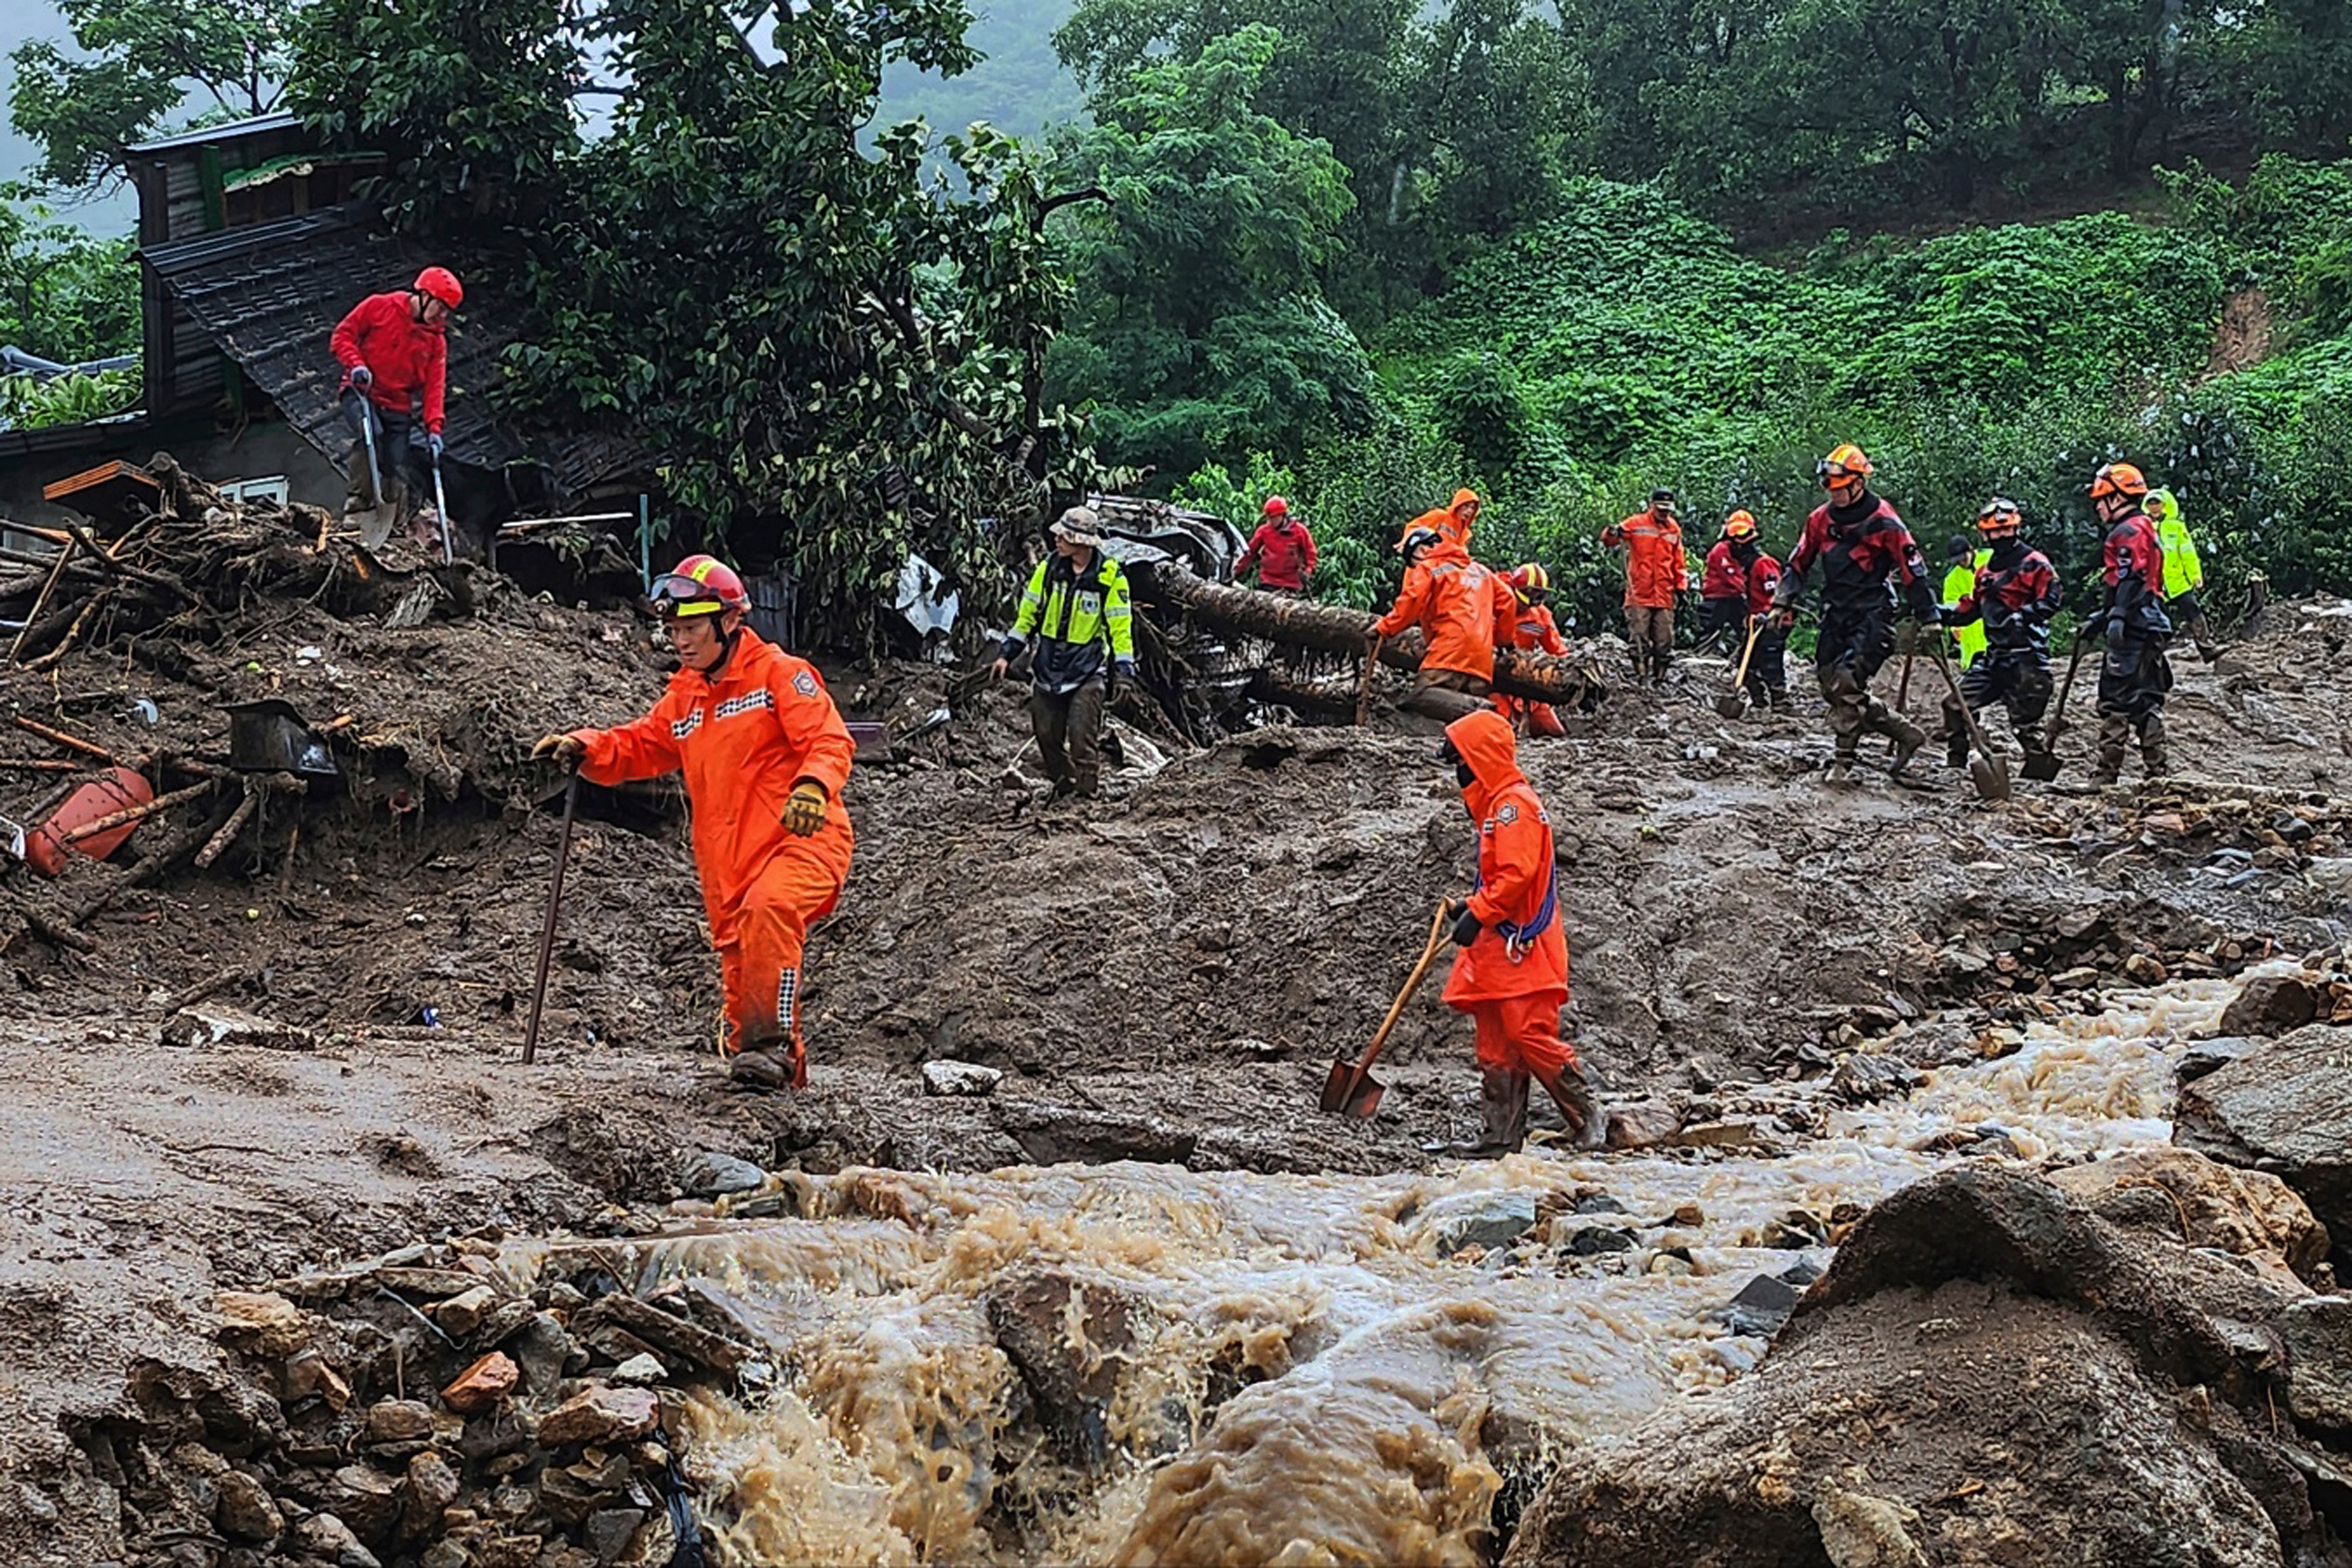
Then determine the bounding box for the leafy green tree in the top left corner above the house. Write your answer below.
[10,0,296,190]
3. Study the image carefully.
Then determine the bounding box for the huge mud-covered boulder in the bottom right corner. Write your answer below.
[1505,1168,2347,1568]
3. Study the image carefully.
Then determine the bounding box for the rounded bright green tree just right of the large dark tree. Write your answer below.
[1047,26,1371,477]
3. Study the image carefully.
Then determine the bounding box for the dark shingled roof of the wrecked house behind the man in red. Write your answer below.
[141,205,654,498]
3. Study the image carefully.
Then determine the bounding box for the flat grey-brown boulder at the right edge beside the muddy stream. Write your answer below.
[2173,1025,2352,1265]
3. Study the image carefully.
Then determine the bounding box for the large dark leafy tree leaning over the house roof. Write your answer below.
[296,0,1103,637]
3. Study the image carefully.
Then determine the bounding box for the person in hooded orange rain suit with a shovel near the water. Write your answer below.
[1440,712,1609,1156]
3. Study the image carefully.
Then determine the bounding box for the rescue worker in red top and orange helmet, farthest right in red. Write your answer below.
[2075,463,2173,785]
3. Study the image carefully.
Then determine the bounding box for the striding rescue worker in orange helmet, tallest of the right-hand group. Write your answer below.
[1774,444,1943,783]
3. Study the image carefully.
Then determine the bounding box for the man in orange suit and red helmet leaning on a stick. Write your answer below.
[531,555,856,1091]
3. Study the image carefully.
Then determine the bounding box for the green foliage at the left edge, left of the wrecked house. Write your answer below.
[0,186,139,362]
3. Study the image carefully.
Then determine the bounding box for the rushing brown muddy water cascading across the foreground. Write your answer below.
[513,983,2234,1563]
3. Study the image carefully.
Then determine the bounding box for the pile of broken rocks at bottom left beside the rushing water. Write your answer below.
[68,1239,771,1568]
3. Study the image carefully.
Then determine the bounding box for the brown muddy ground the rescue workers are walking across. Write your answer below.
[0,496,2352,1563]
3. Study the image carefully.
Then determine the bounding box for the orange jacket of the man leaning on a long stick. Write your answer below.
[571,628,856,947]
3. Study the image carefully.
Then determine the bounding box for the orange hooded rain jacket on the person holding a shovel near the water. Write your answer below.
[1446,710,1569,1006]
